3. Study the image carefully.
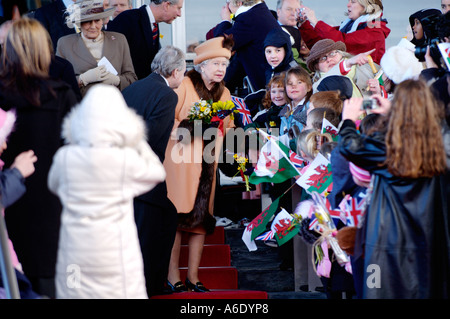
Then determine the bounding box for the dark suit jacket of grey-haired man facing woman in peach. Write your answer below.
[121,72,178,205]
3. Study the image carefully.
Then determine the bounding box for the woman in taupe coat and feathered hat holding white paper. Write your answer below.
[56,0,137,96]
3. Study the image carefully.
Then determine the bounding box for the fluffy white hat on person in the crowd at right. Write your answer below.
[380,46,423,84]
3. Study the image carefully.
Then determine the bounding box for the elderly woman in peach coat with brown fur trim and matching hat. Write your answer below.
[164,37,234,292]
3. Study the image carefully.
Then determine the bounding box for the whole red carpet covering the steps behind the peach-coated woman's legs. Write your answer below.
[152,227,267,299]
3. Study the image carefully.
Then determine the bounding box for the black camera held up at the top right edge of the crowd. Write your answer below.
[414,14,442,65]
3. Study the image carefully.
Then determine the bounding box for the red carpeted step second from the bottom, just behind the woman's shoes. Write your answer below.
[180,266,238,289]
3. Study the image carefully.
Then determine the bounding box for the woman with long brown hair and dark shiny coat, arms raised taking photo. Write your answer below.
[338,80,450,299]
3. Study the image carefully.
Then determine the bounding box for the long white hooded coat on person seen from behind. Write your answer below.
[48,85,166,299]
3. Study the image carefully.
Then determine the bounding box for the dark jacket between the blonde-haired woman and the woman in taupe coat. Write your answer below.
[34,0,75,52]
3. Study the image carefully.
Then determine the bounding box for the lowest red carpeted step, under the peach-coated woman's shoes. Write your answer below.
[151,290,268,299]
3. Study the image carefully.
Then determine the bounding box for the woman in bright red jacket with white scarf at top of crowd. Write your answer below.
[299,0,391,64]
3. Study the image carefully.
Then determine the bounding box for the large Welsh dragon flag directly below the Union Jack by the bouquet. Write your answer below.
[249,138,300,184]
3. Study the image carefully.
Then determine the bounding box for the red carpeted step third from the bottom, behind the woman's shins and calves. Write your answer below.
[180,244,231,267]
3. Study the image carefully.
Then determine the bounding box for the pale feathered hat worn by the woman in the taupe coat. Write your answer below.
[66,0,115,28]
